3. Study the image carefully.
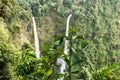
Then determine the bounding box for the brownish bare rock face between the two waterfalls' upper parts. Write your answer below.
[38,13,65,43]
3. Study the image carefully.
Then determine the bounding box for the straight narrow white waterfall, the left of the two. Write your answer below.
[32,17,40,58]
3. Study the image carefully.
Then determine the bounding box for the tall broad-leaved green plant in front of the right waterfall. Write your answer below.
[55,27,90,80]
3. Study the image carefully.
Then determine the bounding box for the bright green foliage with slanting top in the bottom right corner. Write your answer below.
[93,62,120,80]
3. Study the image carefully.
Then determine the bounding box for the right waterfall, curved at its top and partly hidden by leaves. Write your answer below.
[58,14,72,80]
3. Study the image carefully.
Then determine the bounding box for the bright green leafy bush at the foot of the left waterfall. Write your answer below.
[16,44,54,80]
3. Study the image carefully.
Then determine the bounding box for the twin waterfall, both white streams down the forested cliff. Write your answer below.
[32,14,72,80]
